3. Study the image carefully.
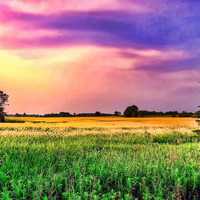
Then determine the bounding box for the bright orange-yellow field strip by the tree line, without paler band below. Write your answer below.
[0,117,197,128]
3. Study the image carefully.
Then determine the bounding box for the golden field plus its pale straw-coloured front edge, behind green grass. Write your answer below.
[0,117,197,136]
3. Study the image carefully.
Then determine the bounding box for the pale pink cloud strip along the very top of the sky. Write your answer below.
[7,0,151,13]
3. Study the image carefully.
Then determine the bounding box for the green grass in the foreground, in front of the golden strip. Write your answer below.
[0,129,200,200]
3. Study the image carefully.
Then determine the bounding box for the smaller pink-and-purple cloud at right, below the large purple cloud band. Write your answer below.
[119,49,200,74]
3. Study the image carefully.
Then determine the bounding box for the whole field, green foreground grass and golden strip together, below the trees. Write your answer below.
[0,117,200,200]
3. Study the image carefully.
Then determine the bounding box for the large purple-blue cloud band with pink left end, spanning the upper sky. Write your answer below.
[0,2,200,49]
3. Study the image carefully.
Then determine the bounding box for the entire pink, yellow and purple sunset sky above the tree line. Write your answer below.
[0,0,200,113]
